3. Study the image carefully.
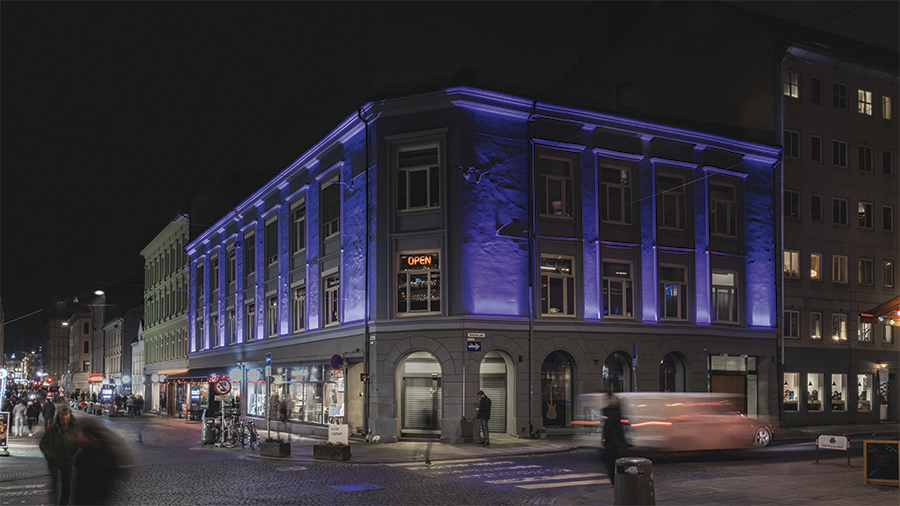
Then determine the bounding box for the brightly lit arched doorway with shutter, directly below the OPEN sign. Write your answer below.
[399,351,442,435]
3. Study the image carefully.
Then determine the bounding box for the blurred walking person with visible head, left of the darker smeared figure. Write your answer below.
[40,407,80,504]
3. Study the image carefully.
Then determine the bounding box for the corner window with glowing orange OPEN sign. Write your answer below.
[397,252,441,314]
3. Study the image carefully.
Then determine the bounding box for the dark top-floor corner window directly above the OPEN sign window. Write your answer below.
[397,146,441,211]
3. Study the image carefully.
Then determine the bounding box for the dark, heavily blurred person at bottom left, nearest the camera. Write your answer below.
[73,418,131,505]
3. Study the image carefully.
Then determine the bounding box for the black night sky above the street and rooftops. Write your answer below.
[0,1,898,351]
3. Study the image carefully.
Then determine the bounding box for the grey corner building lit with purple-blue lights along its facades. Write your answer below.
[185,87,780,443]
